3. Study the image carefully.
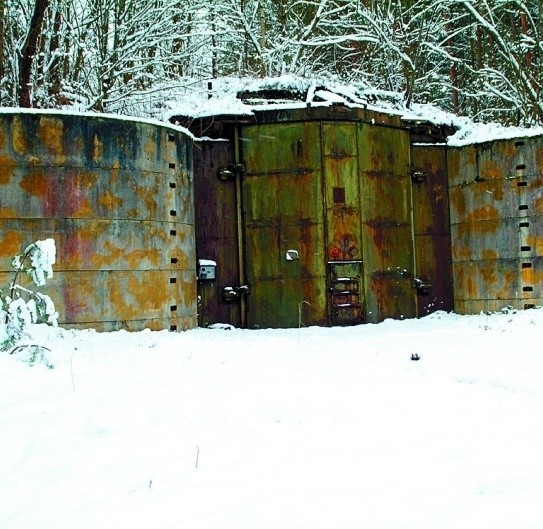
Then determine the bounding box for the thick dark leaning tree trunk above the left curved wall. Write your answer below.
[18,0,50,108]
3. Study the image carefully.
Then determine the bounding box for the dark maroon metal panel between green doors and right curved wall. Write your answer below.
[411,144,454,316]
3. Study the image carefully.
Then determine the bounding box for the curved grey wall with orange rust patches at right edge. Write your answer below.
[449,137,543,313]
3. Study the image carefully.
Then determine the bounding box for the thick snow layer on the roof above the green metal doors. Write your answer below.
[165,75,543,147]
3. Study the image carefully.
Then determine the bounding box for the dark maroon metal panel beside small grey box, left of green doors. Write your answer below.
[194,140,241,327]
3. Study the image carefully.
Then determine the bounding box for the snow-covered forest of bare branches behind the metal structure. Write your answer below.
[0,0,543,126]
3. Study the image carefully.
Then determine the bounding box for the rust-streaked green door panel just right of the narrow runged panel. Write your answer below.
[358,124,416,322]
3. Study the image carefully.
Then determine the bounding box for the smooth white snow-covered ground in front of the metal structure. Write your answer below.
[0,309,543,529]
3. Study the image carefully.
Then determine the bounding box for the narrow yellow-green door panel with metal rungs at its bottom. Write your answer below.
[321,122,364,325]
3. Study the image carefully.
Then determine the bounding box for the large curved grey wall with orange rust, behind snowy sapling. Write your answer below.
[0,112,196,330]
